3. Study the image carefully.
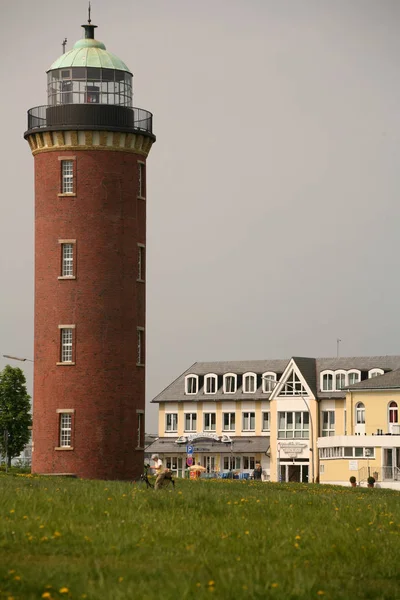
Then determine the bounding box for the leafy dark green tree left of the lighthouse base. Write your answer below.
[0,365,32,466]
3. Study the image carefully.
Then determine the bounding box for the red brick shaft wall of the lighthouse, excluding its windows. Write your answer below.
[32,150,146,479]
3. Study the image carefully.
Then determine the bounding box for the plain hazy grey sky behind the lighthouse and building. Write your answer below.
[0,0,400,433]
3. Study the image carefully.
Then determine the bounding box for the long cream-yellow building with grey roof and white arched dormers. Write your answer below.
[148,356,400,486]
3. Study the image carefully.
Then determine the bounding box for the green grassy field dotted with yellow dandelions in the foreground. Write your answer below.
[0,475,400,600]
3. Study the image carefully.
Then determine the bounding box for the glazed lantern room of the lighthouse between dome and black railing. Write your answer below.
[47,67,132,106]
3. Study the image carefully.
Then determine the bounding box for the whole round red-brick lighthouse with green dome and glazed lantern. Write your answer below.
[24,12,155,479]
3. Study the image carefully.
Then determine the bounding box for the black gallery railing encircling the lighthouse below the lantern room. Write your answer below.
[25,104,154,137]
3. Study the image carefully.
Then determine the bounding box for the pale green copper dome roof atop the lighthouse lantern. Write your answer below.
[49,31,131,73]
